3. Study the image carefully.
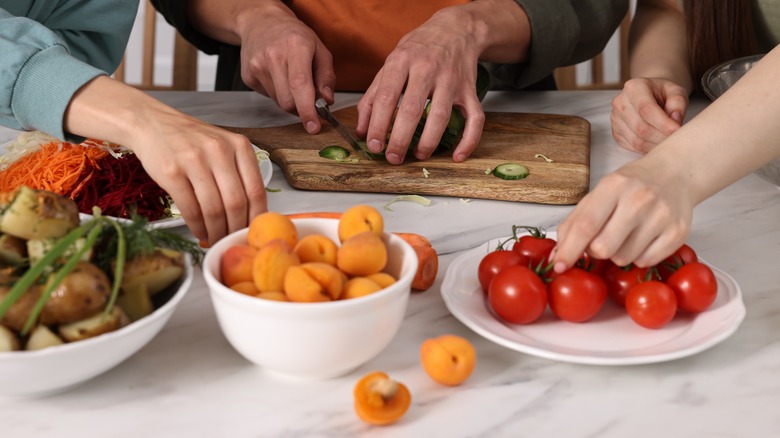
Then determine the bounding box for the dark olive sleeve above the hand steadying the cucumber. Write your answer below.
[489,0,629,89]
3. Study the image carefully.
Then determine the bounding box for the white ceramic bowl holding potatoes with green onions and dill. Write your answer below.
[0,255,193,397]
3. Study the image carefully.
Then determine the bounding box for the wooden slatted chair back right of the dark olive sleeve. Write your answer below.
[554,11,631,90]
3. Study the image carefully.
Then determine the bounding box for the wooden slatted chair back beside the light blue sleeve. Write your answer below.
[114,1,198,91]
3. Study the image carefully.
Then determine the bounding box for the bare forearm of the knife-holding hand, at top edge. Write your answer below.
[187,0,295,46]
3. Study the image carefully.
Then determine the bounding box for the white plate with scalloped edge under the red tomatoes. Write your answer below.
[441,232,745,365]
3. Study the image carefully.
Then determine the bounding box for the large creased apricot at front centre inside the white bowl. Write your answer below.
[284,262,344,303]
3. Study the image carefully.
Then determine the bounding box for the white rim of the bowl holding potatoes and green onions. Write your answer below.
[0,253,195,362]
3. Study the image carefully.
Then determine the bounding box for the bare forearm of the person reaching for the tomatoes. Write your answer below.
[640,47,780,203]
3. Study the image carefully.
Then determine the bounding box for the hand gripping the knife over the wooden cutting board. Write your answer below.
[240,6,336,134]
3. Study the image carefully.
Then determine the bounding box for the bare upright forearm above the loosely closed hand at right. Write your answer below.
[629,0,693,92]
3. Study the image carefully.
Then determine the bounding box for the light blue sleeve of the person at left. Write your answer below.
[0,0,138,139]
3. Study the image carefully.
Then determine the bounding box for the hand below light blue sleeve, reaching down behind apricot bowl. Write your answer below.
[125,112,267,244]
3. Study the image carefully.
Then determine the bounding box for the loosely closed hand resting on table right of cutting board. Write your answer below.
[610,78,688,153]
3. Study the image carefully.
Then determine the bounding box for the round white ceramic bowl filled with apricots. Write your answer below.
[203,218,417,379]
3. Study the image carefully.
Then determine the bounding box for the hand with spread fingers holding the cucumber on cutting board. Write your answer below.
[356,7,485,164]
